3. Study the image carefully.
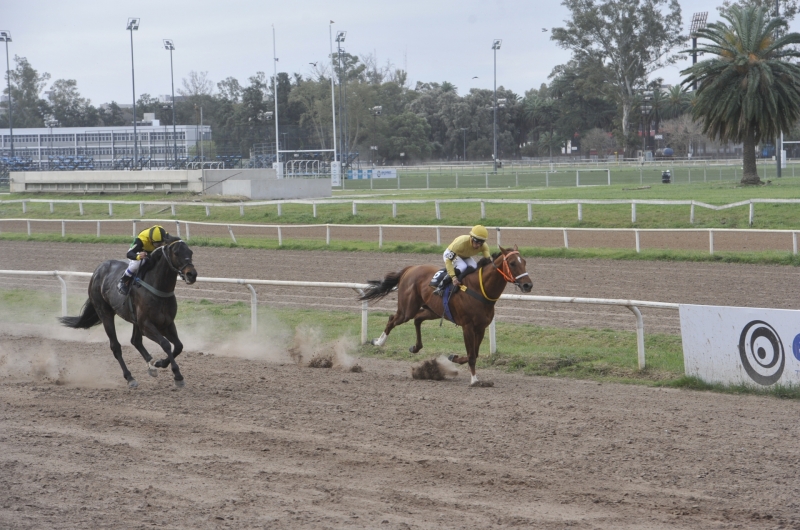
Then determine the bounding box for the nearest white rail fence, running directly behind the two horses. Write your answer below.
[0,270,678,370]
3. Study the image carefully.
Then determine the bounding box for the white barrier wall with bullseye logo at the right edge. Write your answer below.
[679,304,800,386]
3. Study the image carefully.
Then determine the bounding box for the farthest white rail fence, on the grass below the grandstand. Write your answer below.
[0,199,800,226]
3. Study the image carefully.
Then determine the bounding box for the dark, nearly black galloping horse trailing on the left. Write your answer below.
[59,237,197,388]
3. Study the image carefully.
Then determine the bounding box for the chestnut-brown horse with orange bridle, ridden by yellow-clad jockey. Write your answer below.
[359,245,533,384]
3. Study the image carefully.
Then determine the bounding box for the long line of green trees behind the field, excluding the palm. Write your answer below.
[0,0,798,164]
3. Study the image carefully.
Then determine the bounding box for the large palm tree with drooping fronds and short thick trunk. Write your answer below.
[681,6,800,184]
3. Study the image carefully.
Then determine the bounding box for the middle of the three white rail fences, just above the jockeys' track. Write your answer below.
[0,218,798,255]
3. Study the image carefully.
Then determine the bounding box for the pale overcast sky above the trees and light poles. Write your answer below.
[6,0,752,105]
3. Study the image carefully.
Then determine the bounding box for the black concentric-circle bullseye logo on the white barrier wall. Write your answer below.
[739,320,786,386]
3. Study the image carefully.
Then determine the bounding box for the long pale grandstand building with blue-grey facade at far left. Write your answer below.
[0,116,211,170]
